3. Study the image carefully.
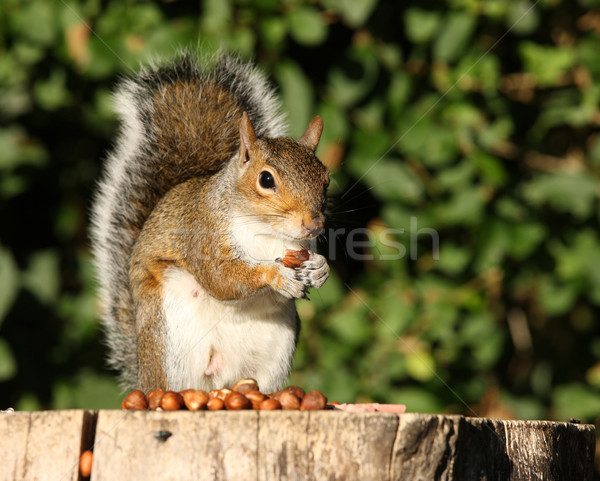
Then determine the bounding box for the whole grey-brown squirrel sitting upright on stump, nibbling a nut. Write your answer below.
[91,52,329,392]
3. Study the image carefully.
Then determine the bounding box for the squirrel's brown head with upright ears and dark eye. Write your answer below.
[238,112,329,241]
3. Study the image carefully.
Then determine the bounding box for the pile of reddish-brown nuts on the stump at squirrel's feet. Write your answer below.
[121,379,328,411]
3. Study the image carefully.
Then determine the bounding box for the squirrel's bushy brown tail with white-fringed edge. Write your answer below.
[91,53,286,388]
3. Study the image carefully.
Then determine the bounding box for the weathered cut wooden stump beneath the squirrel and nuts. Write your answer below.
[0,411,595,481]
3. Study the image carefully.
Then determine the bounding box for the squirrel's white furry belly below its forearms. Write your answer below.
[162,268,296,392]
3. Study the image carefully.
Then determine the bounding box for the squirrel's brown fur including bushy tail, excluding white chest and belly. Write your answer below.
[92,54,329,389]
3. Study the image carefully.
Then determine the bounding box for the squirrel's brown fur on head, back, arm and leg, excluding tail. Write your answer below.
[130,122,329,389]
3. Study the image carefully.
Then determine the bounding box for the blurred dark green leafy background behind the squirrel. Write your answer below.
[0,0,600,466]
